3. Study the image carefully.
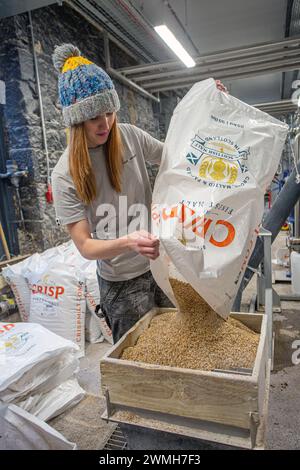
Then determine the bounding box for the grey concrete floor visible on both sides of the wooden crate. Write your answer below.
[8,233,300,449]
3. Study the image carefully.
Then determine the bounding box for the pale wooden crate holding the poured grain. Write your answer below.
[100,309,270,447]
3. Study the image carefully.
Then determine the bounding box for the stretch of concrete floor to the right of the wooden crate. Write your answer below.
[242,232,300,449]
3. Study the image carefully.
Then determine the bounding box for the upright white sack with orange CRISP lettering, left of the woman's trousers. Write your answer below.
[2,241,112,357]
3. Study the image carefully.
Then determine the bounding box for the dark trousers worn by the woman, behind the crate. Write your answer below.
[98,271,174,343]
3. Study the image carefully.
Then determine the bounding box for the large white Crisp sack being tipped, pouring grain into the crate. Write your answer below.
[151,79,288,317]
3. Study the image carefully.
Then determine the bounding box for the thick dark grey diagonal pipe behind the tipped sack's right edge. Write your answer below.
[233,162,300,311]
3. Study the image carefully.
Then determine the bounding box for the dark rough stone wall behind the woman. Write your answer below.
[0,4,178,253]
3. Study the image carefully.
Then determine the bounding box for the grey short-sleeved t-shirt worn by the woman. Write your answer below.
[52,124,163,281]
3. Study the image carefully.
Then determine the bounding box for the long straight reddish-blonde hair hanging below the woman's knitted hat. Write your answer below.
[69,118,123,205]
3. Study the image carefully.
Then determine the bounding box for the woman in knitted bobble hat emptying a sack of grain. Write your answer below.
[52,44,224,342]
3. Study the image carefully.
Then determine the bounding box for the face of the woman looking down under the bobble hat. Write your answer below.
[83,113,116,148]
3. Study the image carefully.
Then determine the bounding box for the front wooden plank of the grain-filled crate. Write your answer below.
[100,359,258,429]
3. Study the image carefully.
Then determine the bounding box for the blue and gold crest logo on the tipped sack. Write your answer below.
[186,134,250,187]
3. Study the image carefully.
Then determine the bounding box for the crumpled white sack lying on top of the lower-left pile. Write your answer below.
[0,322,85,421]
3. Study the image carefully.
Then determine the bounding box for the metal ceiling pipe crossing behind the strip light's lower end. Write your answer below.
[118,38,300,75]
